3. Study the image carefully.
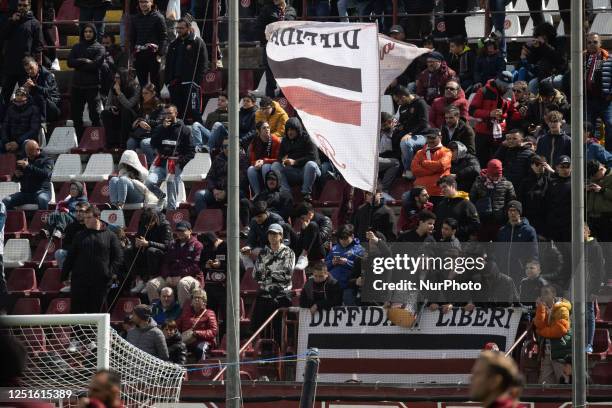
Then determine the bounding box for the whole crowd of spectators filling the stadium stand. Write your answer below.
[0,0,612,383]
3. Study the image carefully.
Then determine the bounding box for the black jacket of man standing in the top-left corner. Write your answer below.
[0,11,44,75]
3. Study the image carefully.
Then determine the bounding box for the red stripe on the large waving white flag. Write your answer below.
[282,86,361,126]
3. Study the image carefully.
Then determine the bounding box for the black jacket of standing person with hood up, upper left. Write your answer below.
[68,23,106,89]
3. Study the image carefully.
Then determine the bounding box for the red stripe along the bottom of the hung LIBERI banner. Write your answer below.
[319,358,475,375]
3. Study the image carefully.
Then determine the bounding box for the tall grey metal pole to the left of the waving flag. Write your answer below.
[225,0,242,408]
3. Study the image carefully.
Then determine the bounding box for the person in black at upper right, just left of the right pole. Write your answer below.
[521,23,567,93]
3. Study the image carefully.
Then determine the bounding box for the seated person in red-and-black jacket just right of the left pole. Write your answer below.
[247,122,281,195]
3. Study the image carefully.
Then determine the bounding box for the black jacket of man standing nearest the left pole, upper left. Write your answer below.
[165,33,208,85]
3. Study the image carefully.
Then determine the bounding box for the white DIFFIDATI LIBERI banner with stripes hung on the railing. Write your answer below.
[296,306,521,384]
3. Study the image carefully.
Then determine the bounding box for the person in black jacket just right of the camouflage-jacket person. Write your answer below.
[294,203,334,264]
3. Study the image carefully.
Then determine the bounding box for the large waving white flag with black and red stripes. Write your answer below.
[266,21,430,191]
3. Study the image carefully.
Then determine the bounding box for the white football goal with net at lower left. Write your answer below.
[0,314,185,407]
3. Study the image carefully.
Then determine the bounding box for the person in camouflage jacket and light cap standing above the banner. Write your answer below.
[251,224,295,337]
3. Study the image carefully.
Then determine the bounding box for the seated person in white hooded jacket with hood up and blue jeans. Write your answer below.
[108,150,158,209]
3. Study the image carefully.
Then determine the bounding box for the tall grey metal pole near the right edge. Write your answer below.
[570,0,587,408]
